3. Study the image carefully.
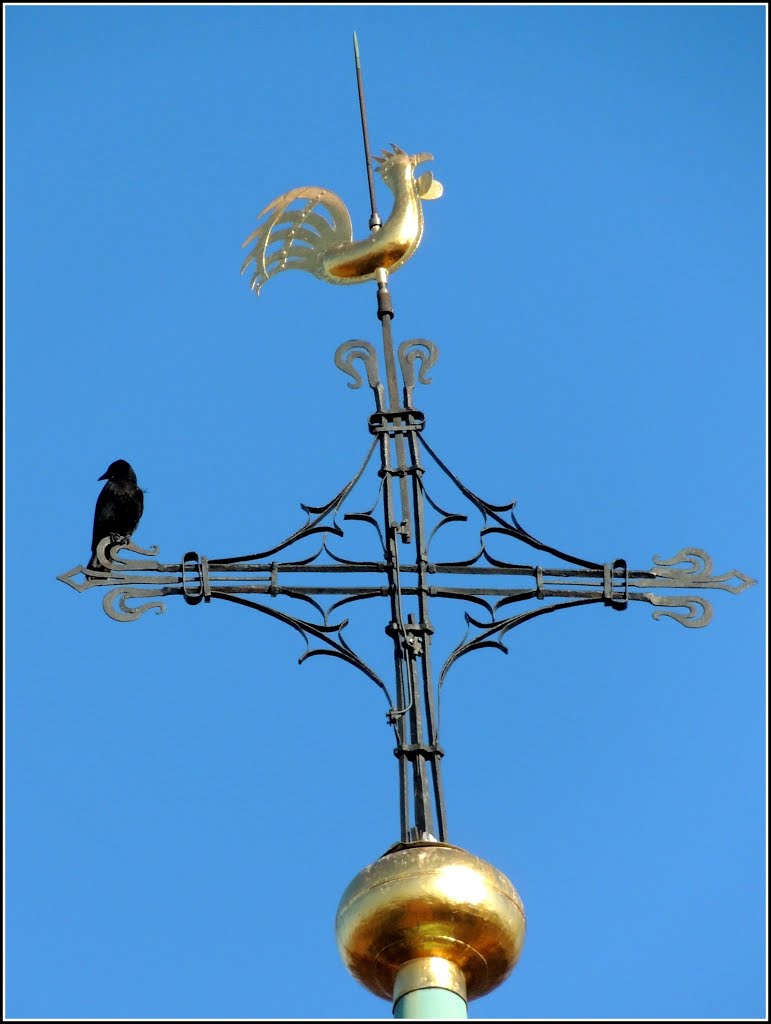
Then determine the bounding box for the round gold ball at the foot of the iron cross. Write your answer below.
[336,843,525,999]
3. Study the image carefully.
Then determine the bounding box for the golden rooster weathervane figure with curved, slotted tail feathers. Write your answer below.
[241,143,442,295]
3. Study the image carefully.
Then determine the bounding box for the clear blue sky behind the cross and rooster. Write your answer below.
[5,5,766,1019]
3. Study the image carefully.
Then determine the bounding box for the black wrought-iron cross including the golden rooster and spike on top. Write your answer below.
[58,37,756,843]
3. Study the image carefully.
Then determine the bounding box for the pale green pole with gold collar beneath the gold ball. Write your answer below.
[393,956,468,1021]
